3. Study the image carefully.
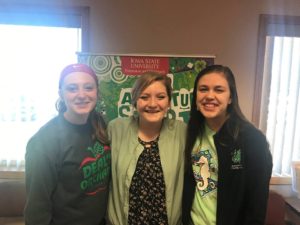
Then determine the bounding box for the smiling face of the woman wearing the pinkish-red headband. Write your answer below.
[59,72,98,124]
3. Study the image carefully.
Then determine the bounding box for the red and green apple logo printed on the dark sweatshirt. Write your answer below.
[79,142,111,195]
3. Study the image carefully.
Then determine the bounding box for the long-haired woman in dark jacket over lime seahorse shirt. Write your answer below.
[182,65,272,225]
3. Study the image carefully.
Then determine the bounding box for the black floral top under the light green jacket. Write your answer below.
[128,137,168,225]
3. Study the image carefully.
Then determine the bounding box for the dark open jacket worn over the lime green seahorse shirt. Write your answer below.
[182,118,272,225]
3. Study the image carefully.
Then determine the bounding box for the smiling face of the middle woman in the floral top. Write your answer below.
[136,81,170,124]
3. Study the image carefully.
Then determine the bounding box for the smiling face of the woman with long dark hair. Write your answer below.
[196,72,231,130]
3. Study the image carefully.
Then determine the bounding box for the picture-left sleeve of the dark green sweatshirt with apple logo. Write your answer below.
[24,135,57,225]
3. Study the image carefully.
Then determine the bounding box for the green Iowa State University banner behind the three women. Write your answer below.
[78,53,214,122]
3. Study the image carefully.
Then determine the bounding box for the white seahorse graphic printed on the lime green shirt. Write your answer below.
[192,150,217,197]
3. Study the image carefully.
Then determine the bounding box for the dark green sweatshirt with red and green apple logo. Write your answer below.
[24,115,111,225]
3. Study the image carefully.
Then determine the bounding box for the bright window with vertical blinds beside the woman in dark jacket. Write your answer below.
[253,15,300,177]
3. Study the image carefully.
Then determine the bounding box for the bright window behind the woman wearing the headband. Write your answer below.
[0,6,88,171]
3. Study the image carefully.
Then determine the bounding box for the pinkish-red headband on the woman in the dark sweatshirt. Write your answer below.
[58,63,98,89]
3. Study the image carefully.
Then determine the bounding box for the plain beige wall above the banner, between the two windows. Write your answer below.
[0,0,300,119]
